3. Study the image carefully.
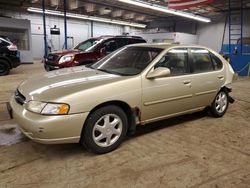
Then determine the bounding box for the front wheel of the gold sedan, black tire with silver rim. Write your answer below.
[81,105,128,154]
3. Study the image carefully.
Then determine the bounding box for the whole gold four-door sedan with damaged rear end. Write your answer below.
[10,44,234,153]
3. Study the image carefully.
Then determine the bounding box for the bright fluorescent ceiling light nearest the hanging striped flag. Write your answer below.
[118,0,211,23]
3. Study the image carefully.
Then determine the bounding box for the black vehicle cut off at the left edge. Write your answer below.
[0,36,20,76]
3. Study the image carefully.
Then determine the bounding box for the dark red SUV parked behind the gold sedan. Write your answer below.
[44,36,146,71]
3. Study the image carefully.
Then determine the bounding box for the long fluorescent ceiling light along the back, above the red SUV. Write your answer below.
[27,7,146,28]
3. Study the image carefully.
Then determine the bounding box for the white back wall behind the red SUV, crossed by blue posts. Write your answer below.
[0,11,141,59]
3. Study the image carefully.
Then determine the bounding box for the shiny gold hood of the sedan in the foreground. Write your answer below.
[18,66,126,102]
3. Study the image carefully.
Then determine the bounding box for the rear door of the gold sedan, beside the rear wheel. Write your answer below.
[190,48,225,107]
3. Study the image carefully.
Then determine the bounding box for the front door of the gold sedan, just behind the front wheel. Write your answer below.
[141,48,194,122]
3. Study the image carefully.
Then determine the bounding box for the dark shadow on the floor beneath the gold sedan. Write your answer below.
[0,112,209,158]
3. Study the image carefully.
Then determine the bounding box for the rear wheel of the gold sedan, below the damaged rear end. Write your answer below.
[210,90,229,118]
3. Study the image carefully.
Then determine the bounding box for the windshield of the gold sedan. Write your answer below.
[90,46,163,76]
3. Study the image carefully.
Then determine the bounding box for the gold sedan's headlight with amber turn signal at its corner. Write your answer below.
[25,101,69,115]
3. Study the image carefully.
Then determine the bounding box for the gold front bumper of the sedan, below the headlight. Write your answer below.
[10,97,88,144]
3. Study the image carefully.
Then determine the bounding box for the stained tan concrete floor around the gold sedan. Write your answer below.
[0,63,250,188]
